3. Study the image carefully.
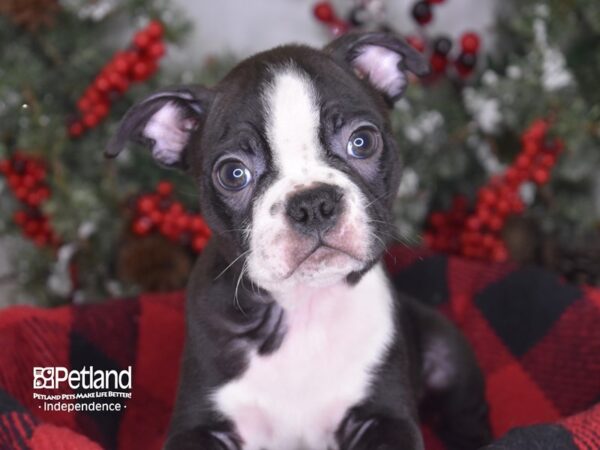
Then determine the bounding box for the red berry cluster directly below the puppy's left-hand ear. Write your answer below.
[131,181,210,252]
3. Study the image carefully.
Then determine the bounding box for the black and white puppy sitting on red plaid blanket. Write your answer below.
[107,33,489,450]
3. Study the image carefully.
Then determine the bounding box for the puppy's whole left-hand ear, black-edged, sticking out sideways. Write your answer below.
[104,87,213,168]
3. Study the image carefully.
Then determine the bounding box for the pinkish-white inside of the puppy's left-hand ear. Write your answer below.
[143,102,194,165]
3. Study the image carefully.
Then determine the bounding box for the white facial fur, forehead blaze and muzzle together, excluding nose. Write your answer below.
[247,66,372,292]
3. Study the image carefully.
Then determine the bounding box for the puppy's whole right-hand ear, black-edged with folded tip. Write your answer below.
[324,32,429,103]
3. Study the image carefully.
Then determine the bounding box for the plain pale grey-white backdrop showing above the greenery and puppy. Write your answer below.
[168,0,496,65]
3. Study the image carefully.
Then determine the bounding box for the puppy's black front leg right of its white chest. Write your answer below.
[336,410,424,450]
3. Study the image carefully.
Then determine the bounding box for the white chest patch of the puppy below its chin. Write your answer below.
[213,266,394,450]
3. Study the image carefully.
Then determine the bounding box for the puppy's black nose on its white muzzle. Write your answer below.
[286,185,342,234]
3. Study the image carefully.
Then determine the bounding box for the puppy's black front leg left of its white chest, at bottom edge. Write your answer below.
[163,427,242,450]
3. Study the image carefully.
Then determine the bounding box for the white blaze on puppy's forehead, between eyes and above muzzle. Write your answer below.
[264,67,320,176]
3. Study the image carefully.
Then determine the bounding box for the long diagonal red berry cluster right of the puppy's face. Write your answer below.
[424,120,563,261]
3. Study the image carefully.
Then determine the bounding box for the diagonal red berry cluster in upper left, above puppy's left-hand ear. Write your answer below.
[68,20,165,138]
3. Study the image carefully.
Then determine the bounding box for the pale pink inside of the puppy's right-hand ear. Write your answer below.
[352,45,407,97]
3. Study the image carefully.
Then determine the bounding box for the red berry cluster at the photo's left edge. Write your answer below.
[0,152,58,246]
